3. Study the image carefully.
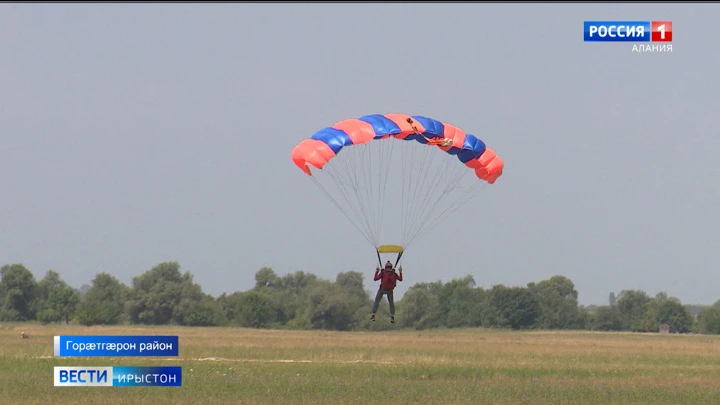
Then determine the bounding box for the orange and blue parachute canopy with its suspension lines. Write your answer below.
[291,114,504,266]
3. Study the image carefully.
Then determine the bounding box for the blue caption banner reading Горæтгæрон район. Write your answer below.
[54,336,178,357]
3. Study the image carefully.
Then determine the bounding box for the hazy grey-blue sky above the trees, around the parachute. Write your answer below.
[0,3,720,305]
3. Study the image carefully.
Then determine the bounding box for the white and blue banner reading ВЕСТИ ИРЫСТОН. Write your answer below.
[53,366,182,387]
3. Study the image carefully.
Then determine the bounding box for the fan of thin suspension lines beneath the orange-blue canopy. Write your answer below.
[304,131,486,252]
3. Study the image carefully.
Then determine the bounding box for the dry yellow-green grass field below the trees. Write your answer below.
[0,324,720,405]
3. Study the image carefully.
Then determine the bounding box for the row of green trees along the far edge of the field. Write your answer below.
[0,262,720,334]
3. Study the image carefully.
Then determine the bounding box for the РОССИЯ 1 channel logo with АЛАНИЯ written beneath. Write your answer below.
[584,21,672,52]
